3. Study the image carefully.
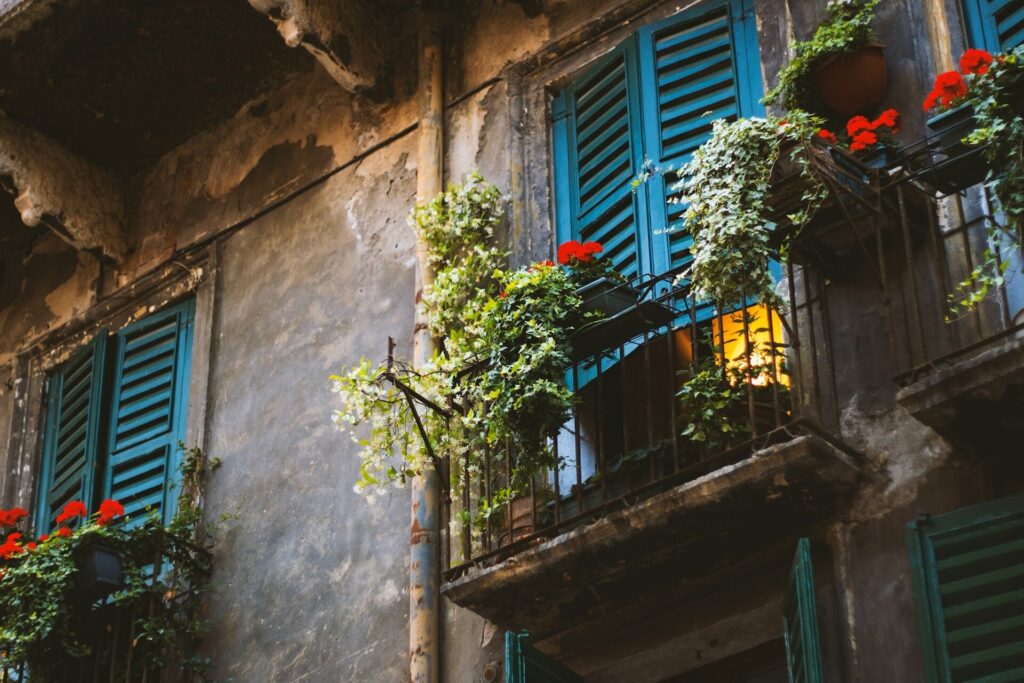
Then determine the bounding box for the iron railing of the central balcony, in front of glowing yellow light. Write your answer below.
[445,263,849,580]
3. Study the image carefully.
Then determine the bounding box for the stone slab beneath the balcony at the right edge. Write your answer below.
[897,337,1024,457]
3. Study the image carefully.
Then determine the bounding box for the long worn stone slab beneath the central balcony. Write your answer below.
[441,436,859,637]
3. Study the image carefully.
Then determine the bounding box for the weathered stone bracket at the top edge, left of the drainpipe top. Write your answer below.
[249,0,381,92]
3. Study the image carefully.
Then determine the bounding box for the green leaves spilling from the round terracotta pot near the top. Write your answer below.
[764,0,882,111]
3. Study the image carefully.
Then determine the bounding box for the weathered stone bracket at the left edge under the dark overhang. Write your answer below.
[0,116,127,261]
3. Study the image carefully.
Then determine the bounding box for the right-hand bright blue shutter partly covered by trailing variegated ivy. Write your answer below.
[639,0,764,286]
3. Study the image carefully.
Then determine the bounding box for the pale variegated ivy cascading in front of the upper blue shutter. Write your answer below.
[674,111,826,304]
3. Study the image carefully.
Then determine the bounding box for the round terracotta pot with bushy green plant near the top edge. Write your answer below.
[764,0,888,117]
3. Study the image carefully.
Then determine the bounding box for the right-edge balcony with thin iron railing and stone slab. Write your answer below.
[886,161,1024,457]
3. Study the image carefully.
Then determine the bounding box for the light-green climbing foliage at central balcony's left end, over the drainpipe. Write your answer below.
[331,174,609,527]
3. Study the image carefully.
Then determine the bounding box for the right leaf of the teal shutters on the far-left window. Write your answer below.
[103,300,195,523]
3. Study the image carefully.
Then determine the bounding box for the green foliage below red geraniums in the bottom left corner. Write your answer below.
[0,444,216,681]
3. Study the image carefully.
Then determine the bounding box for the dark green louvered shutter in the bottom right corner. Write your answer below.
[906,496,1024,682]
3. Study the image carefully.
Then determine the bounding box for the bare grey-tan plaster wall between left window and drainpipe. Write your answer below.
[201,139,416,681]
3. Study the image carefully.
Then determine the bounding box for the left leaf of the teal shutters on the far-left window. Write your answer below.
[35,332,106,532]
